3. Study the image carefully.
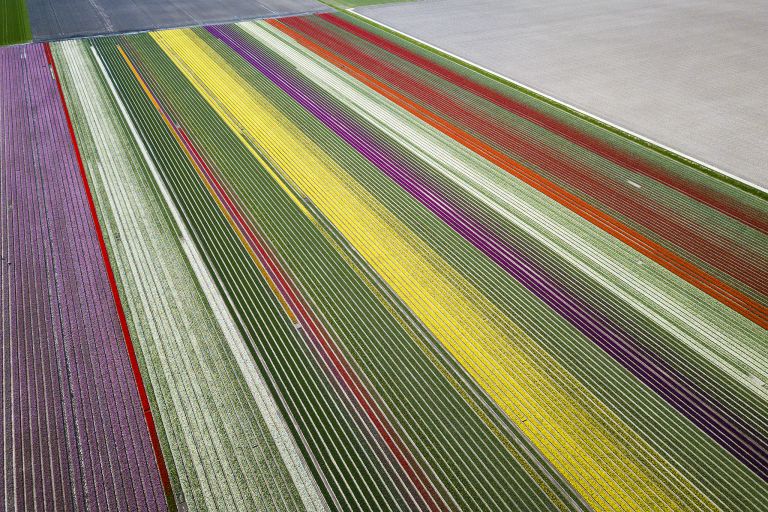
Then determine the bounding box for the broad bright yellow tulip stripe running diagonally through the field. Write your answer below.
[152,30,715,510]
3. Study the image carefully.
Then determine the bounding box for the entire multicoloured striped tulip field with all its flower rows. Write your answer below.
[0,12,768,511]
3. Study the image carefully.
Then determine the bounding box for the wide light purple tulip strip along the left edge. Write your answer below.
[0,45,165,510]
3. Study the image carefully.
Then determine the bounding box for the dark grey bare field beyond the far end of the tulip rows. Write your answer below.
[27,0,328,41]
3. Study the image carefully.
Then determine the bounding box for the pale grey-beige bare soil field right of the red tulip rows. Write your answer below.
[358,0,768,187]
